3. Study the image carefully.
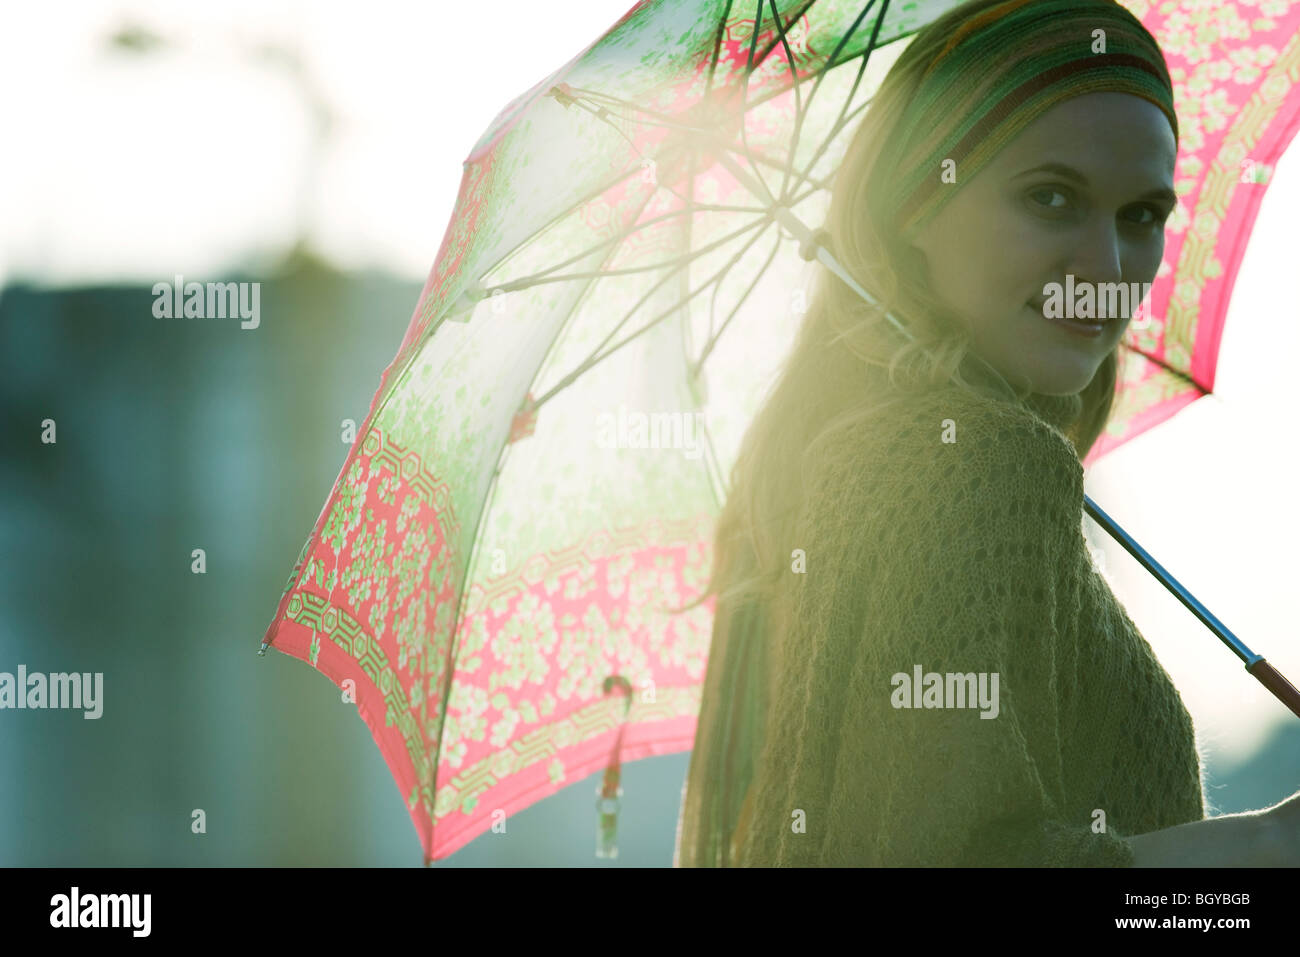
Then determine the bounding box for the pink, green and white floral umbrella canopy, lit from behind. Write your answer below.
[264,0,1300,862]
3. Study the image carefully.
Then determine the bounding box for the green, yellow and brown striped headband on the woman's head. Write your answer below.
[880,0,1178,238]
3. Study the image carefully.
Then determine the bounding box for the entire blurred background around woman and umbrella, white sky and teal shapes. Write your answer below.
[0,0,1300,867]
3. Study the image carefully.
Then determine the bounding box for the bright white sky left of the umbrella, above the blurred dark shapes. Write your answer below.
[0,0,632,282]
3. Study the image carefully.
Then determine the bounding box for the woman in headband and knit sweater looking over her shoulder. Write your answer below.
[675,0,1297,866]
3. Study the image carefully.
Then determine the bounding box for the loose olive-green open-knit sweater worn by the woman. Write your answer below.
[673,369,1204,867]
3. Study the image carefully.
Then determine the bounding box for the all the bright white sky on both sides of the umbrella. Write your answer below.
[0,0,1300,769]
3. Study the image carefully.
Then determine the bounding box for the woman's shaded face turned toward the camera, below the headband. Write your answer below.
[914,92,1177,395]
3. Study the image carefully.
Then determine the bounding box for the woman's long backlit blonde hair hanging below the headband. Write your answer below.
[679,0,1119,616]
